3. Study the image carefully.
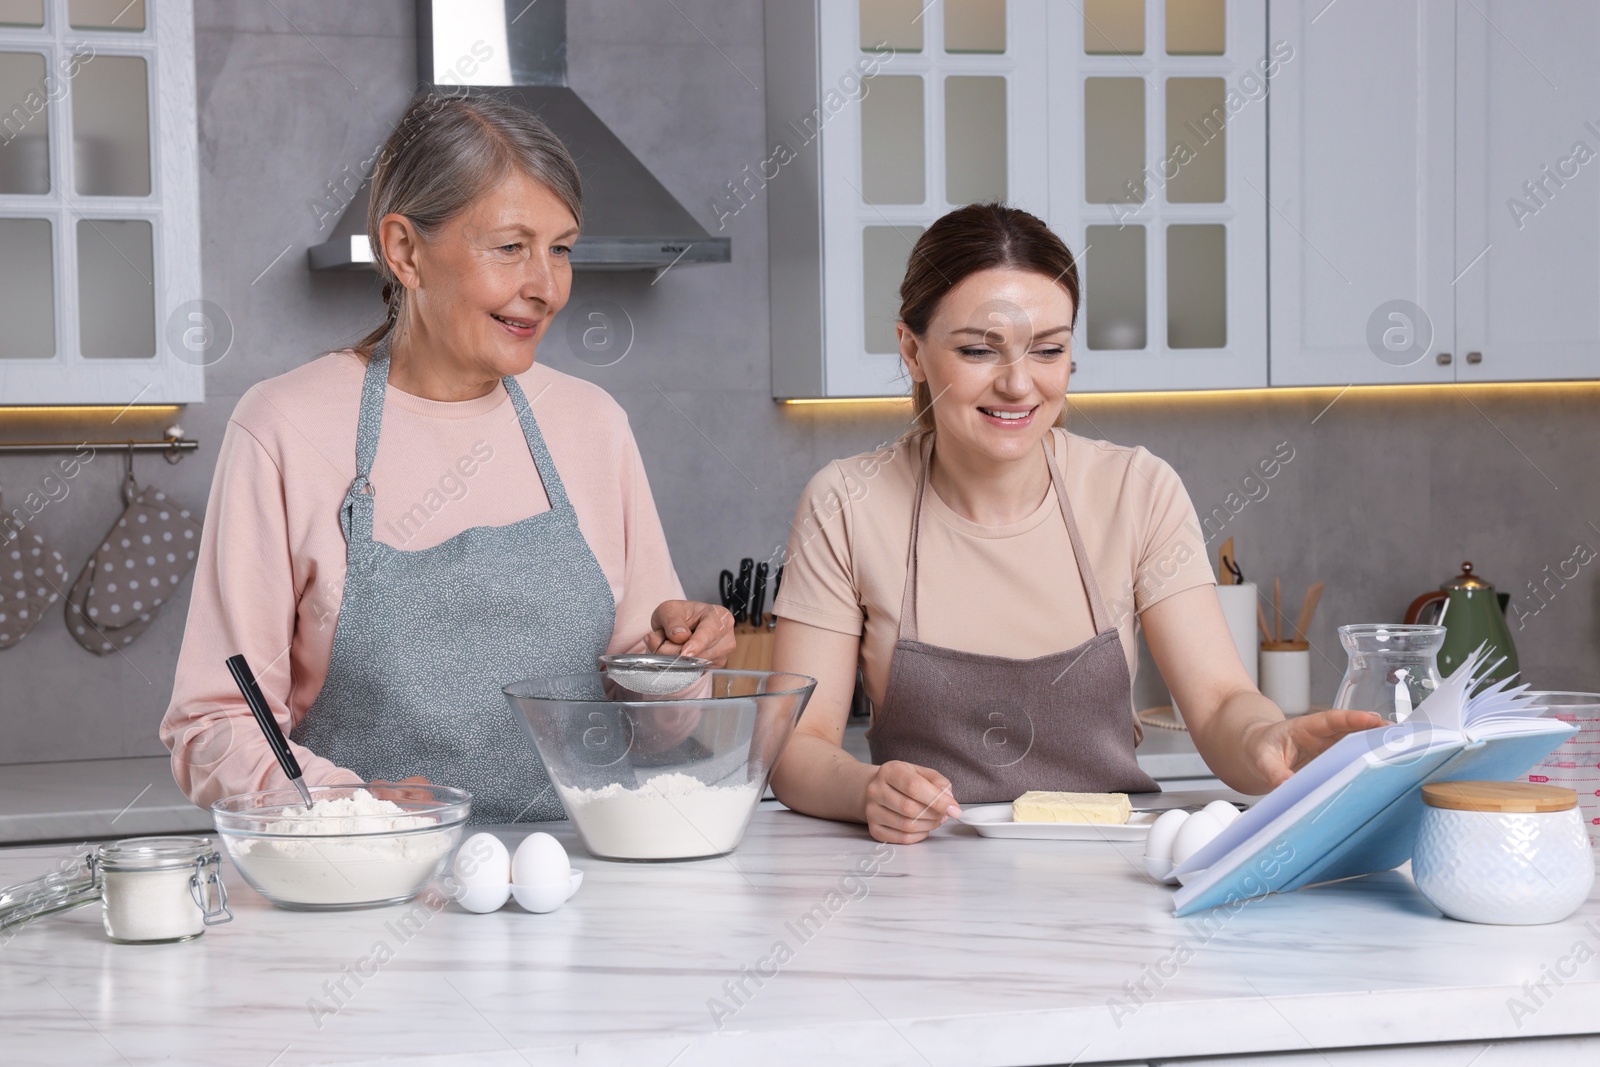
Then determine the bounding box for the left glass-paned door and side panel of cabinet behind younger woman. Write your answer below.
[760,0,1048,398]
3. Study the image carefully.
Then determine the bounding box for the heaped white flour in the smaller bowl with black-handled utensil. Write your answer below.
[229,789,451,905]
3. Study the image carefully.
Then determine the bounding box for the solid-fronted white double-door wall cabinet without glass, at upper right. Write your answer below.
[1269,0,1600,386]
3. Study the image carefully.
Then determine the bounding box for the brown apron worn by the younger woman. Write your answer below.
[867,435,1160,803]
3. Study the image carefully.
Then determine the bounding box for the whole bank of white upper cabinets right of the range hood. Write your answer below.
[763,0,1600,397]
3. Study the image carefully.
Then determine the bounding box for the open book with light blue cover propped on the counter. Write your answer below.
[1173,646,1574,915]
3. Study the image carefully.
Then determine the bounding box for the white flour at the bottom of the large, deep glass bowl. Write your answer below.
[560,773,760,859]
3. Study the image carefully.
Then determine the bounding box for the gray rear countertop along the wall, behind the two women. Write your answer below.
[0,723,1211,845]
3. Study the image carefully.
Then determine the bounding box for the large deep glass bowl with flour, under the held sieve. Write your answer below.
[504,670,816,861]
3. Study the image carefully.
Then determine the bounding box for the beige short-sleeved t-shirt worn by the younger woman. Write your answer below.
[773,429,1216,713]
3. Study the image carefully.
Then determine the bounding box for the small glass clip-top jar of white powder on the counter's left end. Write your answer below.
[90,837,232,944]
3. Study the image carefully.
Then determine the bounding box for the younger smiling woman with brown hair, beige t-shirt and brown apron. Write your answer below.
[773,205,1382,843]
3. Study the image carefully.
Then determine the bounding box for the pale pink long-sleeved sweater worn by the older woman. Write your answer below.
[162,350,683,806]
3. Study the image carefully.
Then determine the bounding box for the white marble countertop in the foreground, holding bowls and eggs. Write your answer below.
[0,803,1600,1067]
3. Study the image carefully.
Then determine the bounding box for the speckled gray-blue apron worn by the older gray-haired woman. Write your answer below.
[291,338,616,822]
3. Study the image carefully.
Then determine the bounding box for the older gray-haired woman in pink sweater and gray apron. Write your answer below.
[162,96,733,821]
